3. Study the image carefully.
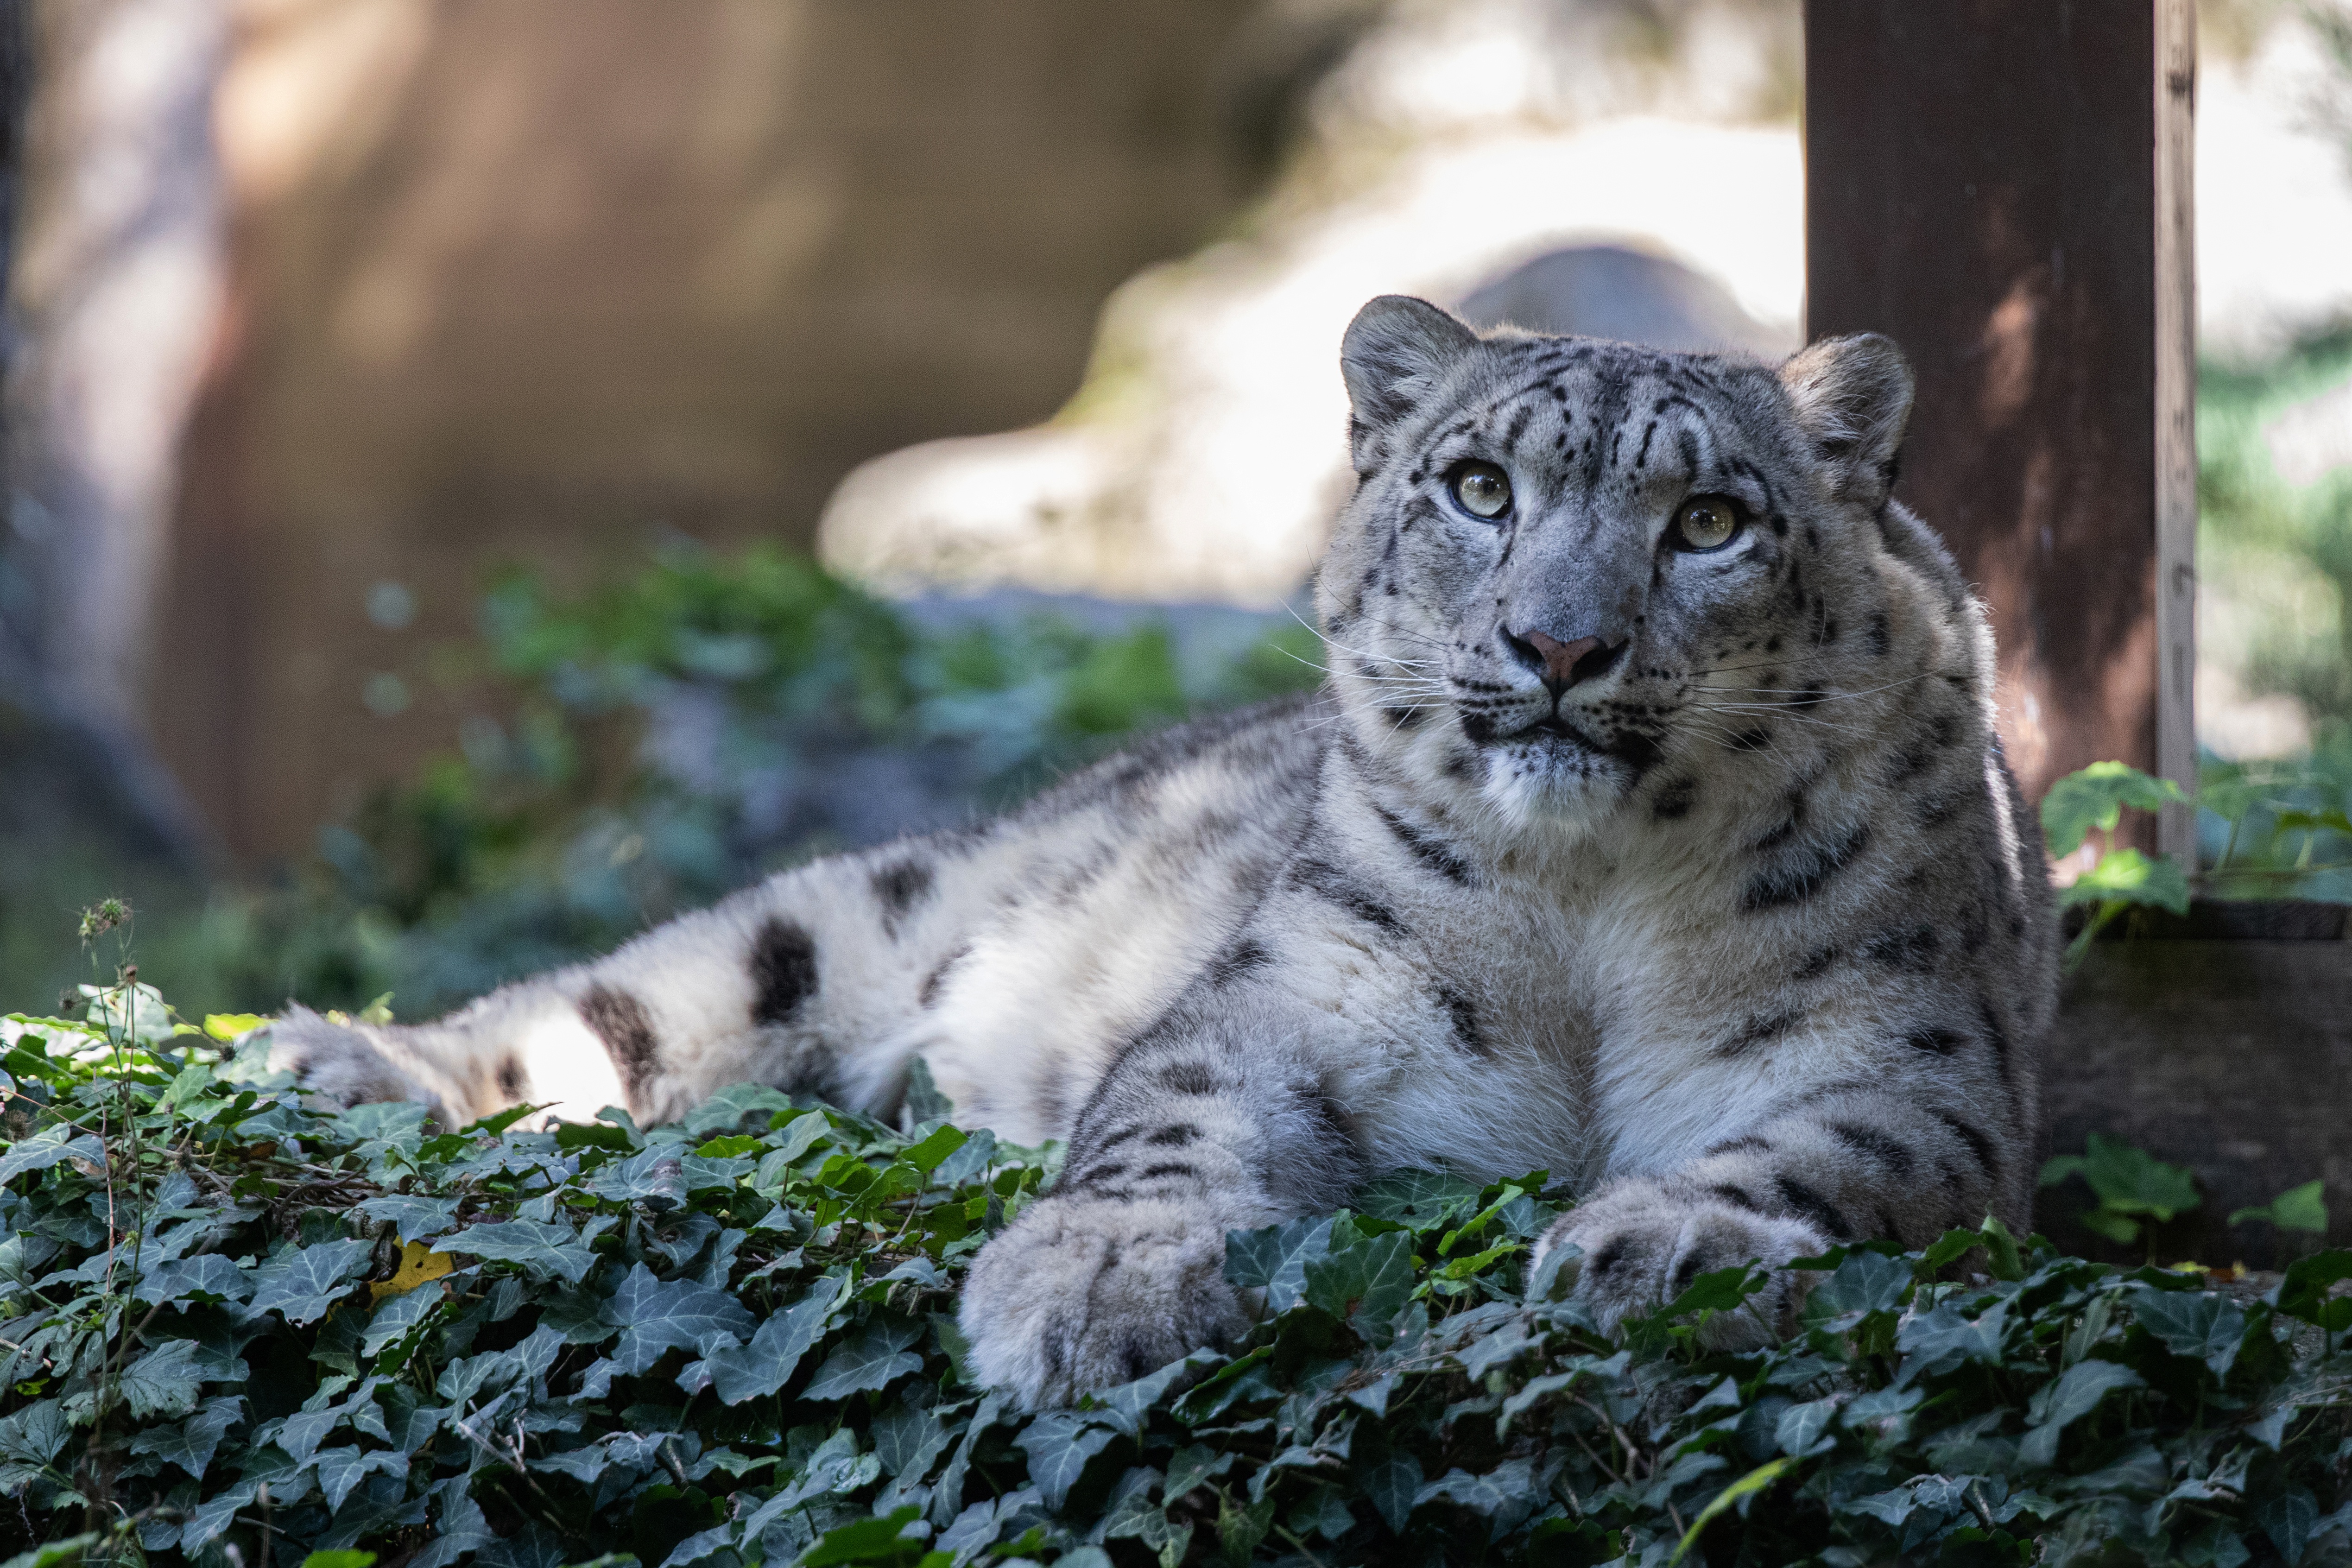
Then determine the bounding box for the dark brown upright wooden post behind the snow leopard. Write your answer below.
[1804,0,2197,854]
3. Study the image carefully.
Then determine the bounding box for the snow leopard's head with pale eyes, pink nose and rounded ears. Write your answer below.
[1317,296,1910,823]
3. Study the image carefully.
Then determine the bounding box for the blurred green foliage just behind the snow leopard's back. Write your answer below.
[27,545,1320,1018]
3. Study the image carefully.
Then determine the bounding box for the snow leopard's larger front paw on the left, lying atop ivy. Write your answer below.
[962,1196,1249,1410]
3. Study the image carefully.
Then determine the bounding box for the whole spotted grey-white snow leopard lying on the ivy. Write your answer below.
[273,296,2055,1406]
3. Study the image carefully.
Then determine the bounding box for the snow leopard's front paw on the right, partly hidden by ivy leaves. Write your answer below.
[1529,1182,1830,1349]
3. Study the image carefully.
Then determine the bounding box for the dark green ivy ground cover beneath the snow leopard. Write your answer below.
[0,990,2352,1568]
